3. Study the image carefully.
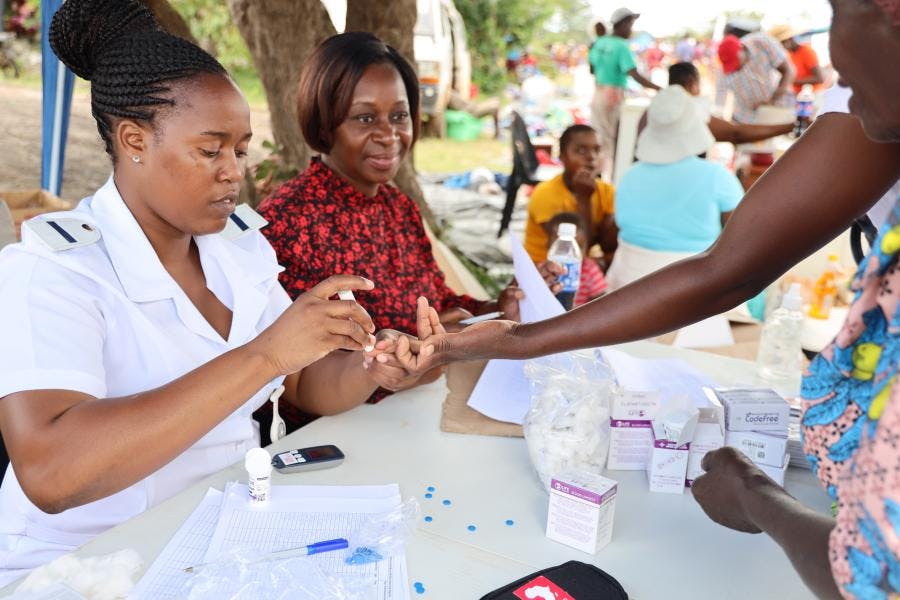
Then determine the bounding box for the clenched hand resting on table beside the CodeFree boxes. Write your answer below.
[691,447,787,533]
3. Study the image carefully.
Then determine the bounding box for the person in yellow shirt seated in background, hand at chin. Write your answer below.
[525,125,618,268]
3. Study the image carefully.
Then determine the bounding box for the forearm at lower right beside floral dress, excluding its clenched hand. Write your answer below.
[744,480,841,598]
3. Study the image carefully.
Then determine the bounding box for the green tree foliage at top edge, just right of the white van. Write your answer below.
[455,0,592,94]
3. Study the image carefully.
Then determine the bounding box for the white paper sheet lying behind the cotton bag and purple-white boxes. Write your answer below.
[601,348,716,407]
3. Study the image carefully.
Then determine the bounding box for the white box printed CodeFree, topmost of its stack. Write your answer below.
[715,388,791,435]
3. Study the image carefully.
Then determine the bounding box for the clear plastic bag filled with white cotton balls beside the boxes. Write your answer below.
[523,350,616,490]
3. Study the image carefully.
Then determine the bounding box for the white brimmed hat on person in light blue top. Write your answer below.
[635,85,715,164]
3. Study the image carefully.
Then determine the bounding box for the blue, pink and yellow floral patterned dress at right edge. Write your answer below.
[801,201,900,600]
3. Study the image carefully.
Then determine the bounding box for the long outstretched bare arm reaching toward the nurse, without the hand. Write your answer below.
[444,114,900,358]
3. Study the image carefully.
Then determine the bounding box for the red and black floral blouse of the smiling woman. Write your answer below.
[258,158,484,335]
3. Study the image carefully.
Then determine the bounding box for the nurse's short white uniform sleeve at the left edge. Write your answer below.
[0,253,106,398]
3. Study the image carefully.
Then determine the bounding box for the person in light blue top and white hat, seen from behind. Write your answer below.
[606,85,744,290]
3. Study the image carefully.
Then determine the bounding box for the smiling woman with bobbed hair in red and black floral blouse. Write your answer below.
[259,32,553,430]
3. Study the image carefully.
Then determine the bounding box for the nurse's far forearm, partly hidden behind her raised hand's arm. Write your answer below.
[294,351,378,416]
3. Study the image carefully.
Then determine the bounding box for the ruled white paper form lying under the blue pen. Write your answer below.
[203,484,409,600]
